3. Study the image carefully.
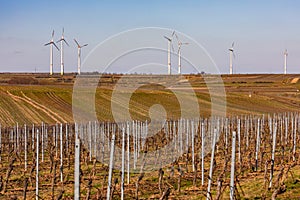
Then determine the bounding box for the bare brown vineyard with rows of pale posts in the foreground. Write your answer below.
[0,113,300,199]
